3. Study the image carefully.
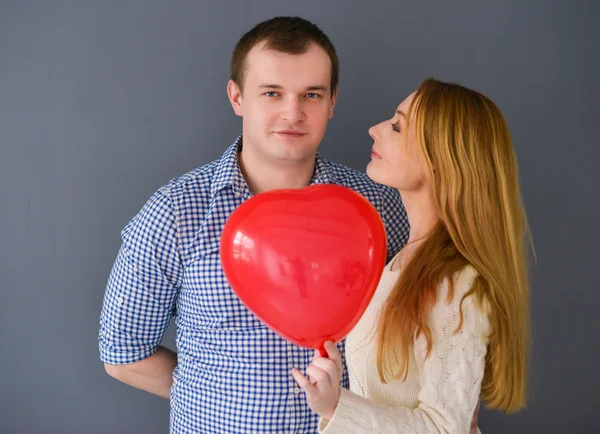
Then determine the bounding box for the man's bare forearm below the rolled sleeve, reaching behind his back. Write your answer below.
[104,346,177,399]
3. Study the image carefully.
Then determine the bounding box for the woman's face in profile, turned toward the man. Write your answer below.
[367,92,427,192]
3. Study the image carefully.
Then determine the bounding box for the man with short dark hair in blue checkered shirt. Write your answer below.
[99,17,408,434]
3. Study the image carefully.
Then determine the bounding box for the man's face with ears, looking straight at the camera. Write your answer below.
[228,43,336,164]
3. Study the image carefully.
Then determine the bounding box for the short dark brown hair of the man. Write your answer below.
[231,17,339,95]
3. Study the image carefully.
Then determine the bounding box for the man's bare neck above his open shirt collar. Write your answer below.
[238,147,316,194]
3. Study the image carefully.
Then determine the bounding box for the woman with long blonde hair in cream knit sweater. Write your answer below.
[293,79,529,434]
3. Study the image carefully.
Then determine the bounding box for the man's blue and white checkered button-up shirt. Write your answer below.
[99,137,409,434]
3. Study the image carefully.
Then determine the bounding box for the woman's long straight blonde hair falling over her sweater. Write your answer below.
[377,79,530,413]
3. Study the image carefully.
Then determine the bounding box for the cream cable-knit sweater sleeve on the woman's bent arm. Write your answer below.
[319,267,490,434]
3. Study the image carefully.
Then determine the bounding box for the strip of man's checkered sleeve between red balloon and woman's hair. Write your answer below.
[380,186,410,264]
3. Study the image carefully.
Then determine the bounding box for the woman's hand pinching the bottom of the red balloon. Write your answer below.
[292,341,344,420]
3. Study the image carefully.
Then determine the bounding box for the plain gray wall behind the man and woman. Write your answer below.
[0,0,600,434]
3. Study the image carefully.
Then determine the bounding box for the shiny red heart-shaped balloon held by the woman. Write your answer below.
[220,184,387,354]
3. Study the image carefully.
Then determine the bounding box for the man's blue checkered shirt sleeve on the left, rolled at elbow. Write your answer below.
[98,187,183,364]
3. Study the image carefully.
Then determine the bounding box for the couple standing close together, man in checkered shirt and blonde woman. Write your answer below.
[99,17,528,434]
